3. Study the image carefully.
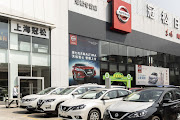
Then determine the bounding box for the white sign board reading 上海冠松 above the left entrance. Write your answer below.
[11,21,49,39]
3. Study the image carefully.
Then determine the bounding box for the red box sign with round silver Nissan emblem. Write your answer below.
[108,0,132,33]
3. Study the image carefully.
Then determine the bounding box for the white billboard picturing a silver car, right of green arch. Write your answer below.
[136,65,169,85]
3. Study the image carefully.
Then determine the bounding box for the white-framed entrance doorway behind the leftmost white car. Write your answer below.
[18,77,44,97]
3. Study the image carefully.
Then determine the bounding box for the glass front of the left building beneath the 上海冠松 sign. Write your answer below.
[0,17,51,101]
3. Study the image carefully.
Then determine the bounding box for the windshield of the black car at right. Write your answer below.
[123,90,163,102]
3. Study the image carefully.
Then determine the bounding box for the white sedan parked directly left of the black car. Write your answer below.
[59,88,131,120]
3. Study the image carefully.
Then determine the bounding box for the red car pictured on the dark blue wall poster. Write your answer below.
[72,63,96,81]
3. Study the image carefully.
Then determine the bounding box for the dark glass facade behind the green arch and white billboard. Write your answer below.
[100,41,180,86]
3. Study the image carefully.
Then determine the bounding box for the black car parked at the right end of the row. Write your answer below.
[103,88,180,120]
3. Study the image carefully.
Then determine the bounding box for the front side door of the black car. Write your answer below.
[162,91,177,120]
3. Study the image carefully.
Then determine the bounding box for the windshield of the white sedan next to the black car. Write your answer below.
[80,90,106,99]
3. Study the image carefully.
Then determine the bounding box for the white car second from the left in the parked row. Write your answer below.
[37,84,103,114]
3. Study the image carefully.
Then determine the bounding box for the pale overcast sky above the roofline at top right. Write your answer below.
[147,0,180,17]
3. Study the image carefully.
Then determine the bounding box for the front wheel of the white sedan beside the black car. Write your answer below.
[88,109,101,120]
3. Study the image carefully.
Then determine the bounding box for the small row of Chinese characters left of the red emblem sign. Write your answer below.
[74,0,97,11]
